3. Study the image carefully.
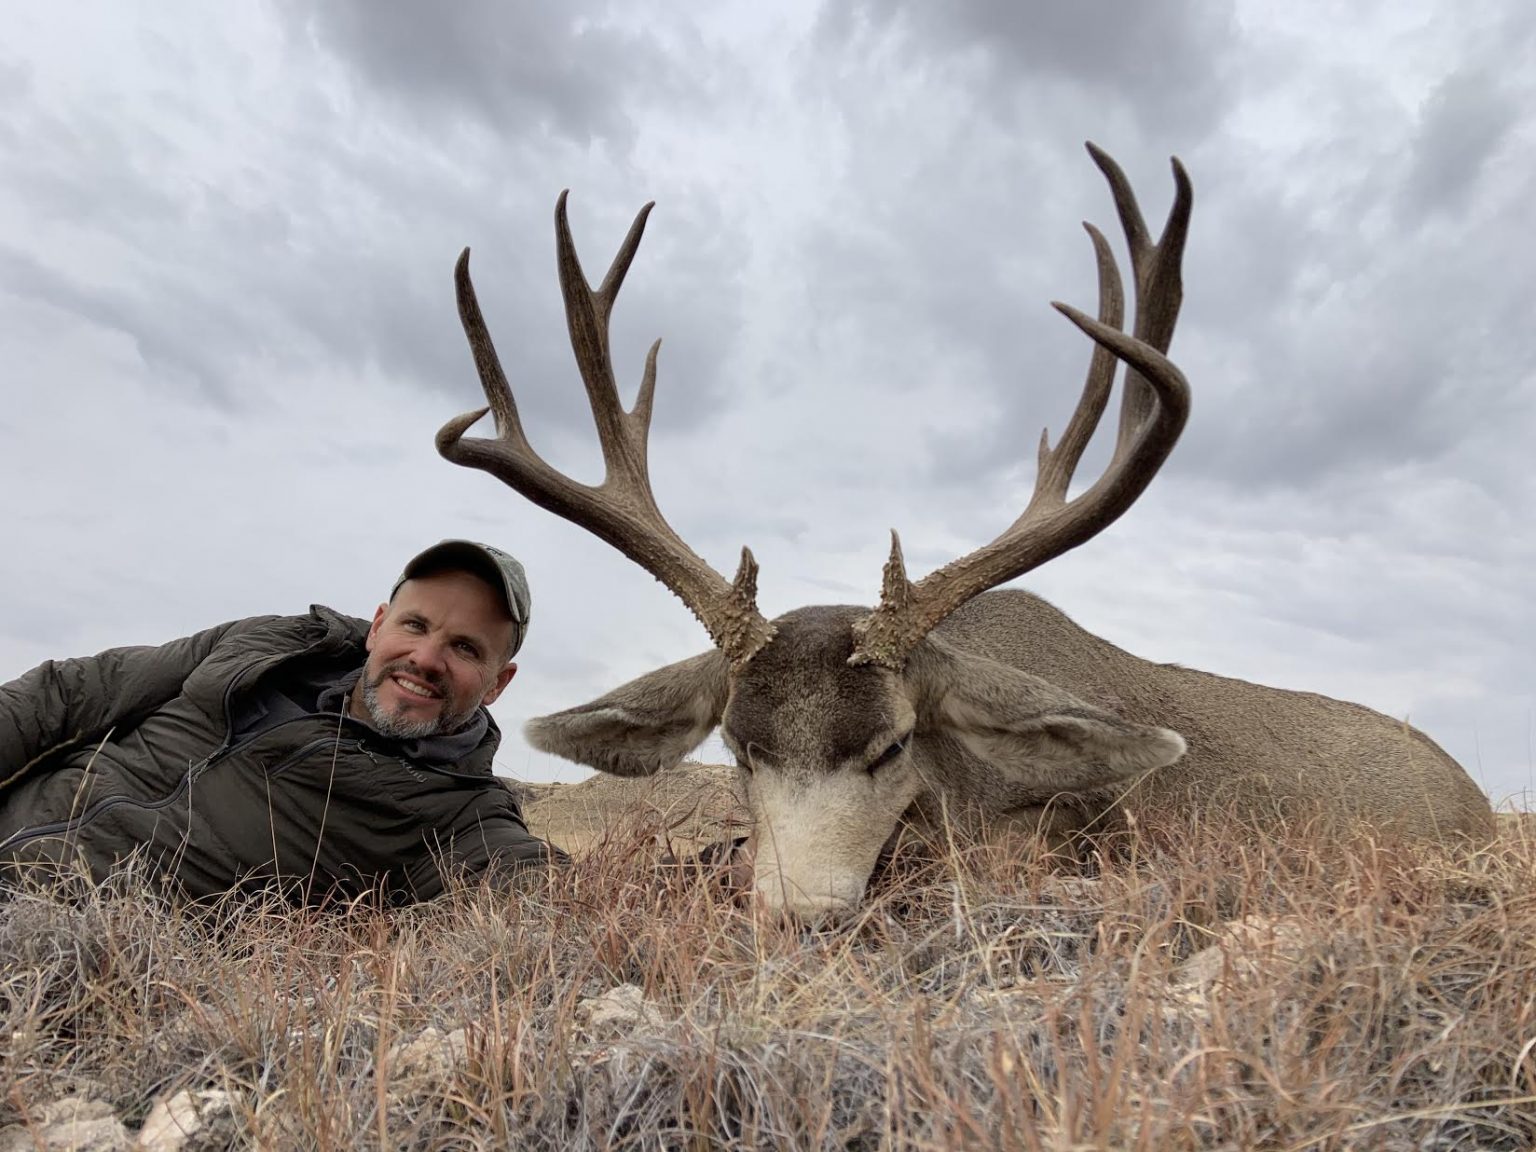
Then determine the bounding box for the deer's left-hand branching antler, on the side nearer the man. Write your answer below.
[438,192,773,667]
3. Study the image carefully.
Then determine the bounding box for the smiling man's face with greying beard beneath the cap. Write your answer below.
[352,570,518,739]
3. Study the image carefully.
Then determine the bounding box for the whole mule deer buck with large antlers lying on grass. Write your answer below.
[438,144,1493,914]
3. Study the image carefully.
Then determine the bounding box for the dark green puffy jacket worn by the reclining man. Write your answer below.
[0,605,559,903]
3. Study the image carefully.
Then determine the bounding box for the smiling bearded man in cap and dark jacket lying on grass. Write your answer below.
[0,541,559,903]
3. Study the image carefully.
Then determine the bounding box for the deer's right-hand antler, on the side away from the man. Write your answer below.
[849,144,1193,668]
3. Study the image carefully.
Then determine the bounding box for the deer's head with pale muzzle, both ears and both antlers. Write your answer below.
[438,144,1192,912]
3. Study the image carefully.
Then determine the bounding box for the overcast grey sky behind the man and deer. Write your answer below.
[0,0,1536,799]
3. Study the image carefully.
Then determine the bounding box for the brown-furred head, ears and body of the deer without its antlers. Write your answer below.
[527,590,1493,911]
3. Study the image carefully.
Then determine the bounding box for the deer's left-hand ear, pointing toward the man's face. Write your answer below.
[522,650,728,776]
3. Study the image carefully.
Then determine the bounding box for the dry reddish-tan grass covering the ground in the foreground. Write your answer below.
[0,823,1536,1149]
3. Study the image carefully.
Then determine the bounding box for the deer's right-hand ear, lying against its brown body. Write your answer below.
[908,637,1184,803]
